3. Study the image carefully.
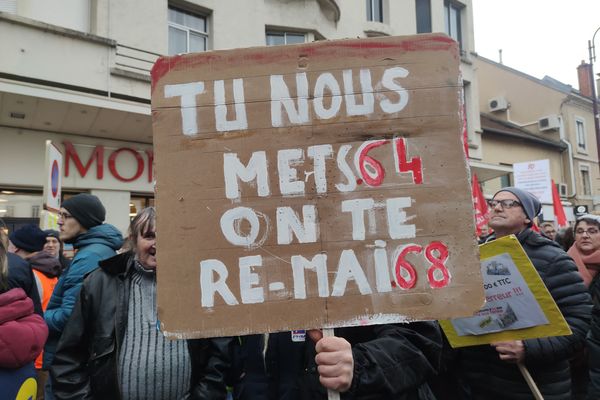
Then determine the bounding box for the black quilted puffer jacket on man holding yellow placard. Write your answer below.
[458,229,592,400]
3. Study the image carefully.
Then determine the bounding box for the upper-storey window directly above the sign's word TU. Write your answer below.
[169,7,208,55]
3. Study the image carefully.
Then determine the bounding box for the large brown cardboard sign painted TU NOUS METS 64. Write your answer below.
[152,34,483,337]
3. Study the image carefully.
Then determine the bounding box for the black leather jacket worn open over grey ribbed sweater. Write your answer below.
[50,253,233,400]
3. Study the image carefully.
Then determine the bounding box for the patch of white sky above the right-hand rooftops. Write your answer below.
[473,0,600,89]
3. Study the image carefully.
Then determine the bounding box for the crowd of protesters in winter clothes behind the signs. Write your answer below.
[0,191,600,400]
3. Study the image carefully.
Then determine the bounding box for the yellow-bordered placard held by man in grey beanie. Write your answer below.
[440,235,571,347]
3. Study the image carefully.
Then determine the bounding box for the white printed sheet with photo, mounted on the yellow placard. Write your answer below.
[452,253,548,336]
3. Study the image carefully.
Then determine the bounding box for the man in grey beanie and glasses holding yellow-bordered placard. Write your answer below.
[459,187,591,400]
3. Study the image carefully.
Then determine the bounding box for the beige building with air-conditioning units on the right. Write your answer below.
[471,57,600,220]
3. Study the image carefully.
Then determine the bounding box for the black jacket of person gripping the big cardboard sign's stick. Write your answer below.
[234,322,441,400]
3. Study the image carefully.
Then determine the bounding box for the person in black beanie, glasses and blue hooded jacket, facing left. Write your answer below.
[43,193,123,400]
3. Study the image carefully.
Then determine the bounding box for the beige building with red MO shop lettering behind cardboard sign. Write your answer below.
[0,0,482,229]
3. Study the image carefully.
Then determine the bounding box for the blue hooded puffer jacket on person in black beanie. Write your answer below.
[44,224,123,369]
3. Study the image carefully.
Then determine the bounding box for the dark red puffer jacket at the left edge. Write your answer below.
[0,288,48,369]
